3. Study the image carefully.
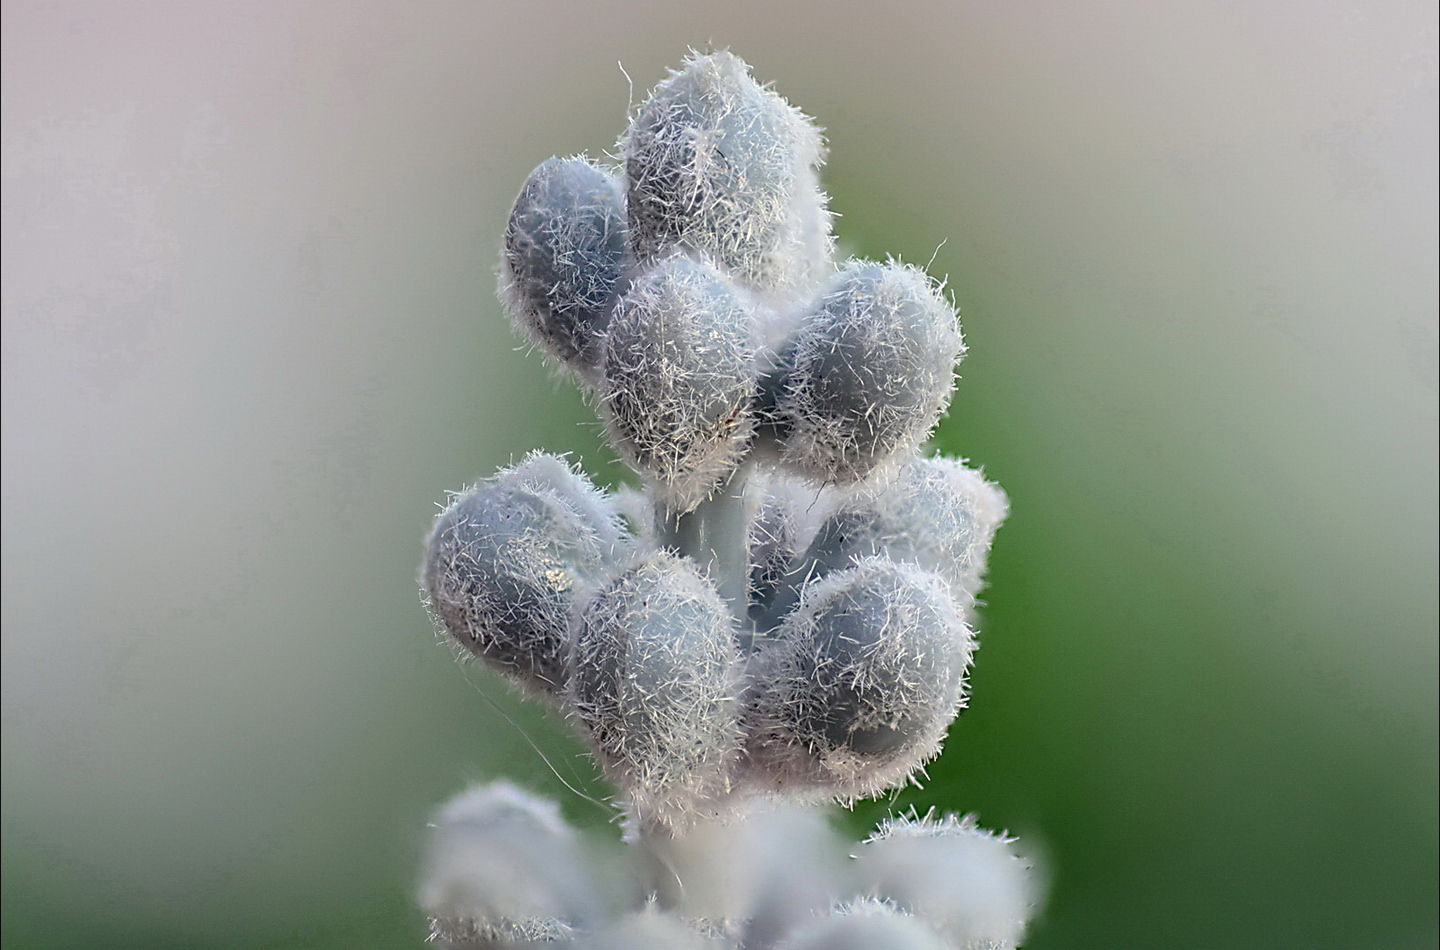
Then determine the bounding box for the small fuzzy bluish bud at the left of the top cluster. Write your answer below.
[500,158,629,376]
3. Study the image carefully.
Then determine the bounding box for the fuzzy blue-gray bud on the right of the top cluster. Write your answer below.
[775,261,965,482]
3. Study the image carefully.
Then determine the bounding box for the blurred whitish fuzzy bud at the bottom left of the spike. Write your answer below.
[419,782,600,946]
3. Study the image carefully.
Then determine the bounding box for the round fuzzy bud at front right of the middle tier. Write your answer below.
[746,557,973,799]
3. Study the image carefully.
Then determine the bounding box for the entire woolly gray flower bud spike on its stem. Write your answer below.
[422,52,1032,950]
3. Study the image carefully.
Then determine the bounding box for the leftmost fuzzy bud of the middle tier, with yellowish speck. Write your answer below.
[420,455,621,694]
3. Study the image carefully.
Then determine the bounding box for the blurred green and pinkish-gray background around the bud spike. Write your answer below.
[3,0,1437,950]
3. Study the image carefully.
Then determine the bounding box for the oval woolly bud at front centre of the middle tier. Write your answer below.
[570,551,739,828]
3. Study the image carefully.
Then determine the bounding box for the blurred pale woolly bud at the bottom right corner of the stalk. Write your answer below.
[855,813,1038,947]
